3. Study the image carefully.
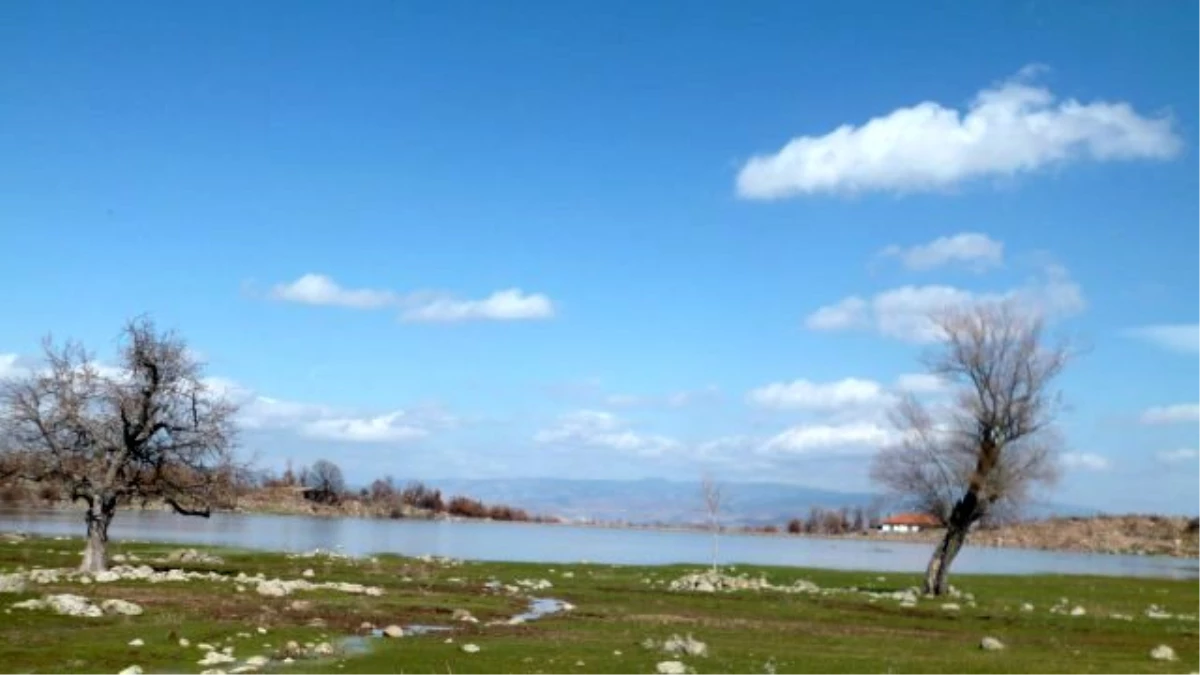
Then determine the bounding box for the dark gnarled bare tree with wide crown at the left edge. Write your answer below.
[0,318,239,572]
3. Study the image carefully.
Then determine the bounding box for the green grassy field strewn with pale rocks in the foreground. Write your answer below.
[0,538,1200,675]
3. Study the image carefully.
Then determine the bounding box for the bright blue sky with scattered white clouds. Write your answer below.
[0,0,1200,513]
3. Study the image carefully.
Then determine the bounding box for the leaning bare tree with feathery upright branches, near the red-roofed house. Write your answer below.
[871,303,1072,595]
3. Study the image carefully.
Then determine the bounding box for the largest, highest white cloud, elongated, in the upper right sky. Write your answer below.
[737,68,1183,199]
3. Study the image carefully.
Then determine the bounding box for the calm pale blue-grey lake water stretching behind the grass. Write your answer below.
[0,512,1200,579]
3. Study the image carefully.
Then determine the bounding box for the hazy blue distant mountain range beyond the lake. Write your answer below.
[408,478,1094,525]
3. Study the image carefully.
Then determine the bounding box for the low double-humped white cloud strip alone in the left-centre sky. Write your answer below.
[268,274,554,323]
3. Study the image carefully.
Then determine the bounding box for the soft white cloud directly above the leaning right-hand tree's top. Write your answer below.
[806,265,1086,344]
